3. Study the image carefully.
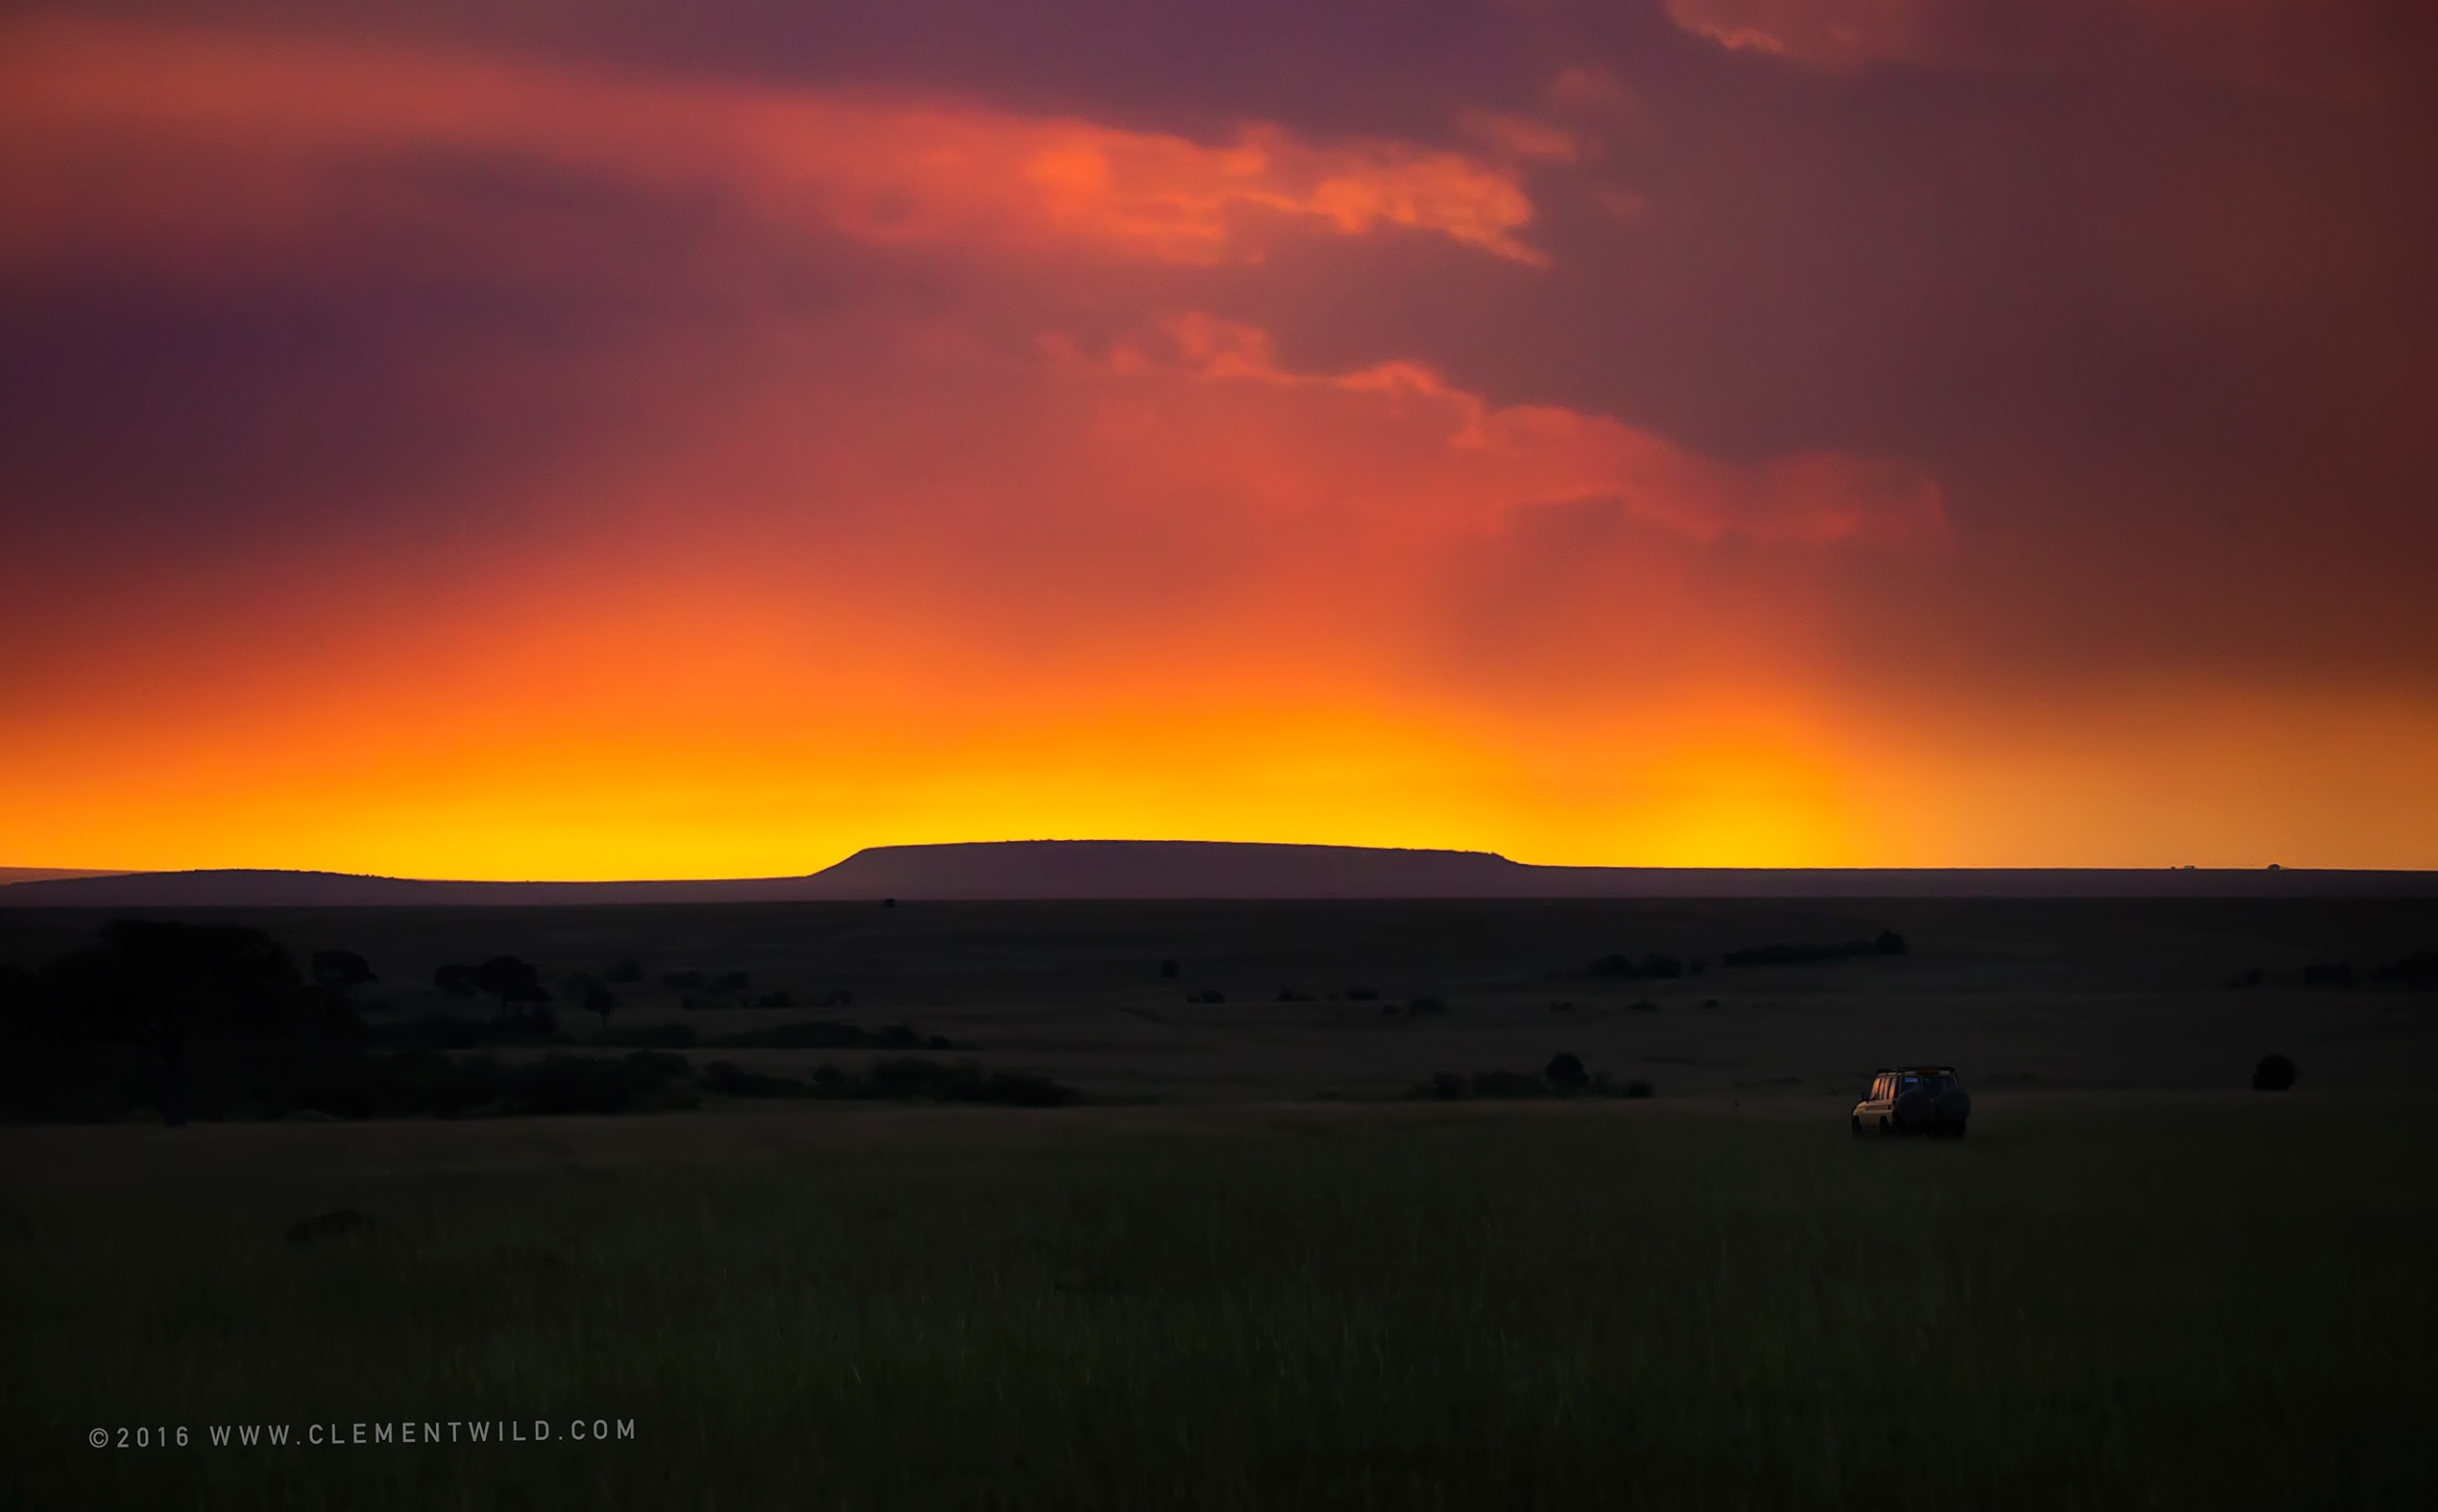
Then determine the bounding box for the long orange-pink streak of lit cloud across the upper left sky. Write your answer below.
[0,19,1543,263]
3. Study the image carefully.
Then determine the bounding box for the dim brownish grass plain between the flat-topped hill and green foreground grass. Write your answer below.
[0,898,2438,1102]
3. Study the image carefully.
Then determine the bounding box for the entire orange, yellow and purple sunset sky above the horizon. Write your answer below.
[0,0,2438,878]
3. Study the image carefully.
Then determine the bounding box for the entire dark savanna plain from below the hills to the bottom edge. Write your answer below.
[0,898,2438,1507]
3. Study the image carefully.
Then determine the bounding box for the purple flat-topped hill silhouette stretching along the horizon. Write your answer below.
[0,839,2438,907]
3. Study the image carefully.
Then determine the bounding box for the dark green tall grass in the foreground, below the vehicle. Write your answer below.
[0,1102,2438,1512]
